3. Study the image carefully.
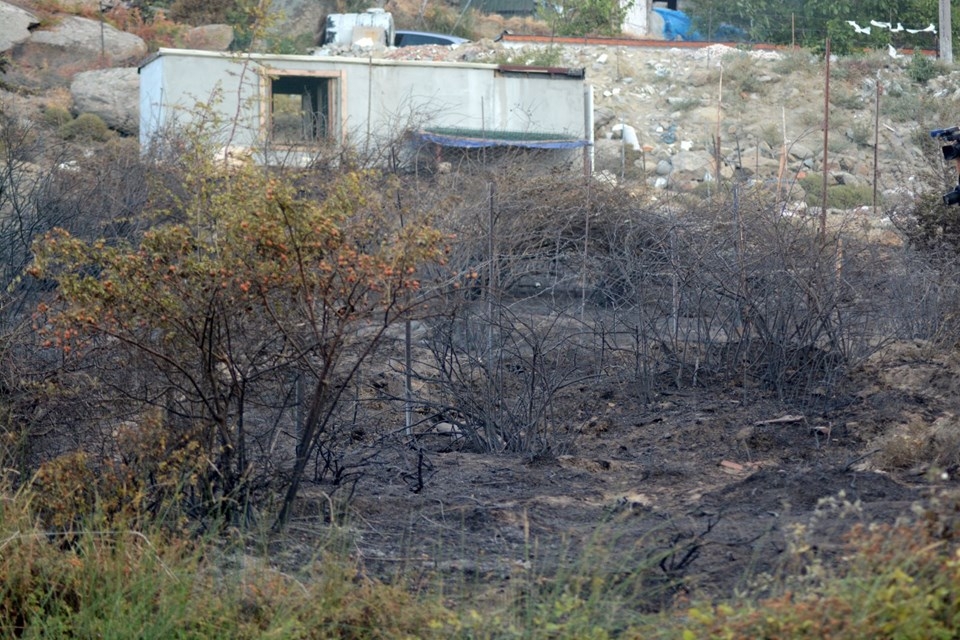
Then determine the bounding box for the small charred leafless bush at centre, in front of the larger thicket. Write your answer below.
[419,302,596,454]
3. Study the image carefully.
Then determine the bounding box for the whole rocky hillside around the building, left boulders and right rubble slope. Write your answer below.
[0,0,960,215]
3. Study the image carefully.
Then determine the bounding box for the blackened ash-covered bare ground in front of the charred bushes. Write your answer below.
[281,343,958,608]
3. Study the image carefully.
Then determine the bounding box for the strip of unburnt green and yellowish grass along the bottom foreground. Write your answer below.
[0,460,960,640]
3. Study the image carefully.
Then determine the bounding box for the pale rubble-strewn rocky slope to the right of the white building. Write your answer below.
[404,41,960,215]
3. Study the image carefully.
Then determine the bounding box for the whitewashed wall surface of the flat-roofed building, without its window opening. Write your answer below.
[140,49,587,161]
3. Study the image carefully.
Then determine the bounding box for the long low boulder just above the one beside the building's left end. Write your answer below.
[29,16,147,63]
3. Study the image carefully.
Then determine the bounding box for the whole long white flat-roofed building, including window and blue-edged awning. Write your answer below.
[140,49,593,170]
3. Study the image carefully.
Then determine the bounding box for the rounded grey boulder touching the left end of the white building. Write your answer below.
[70,67,140,135]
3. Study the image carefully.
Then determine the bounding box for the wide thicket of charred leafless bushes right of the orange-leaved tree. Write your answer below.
[410,170,955,430]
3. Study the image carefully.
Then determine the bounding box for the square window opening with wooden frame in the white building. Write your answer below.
[270,76,334,145]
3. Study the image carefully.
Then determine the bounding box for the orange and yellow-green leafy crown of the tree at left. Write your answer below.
[30,167,445,347]
